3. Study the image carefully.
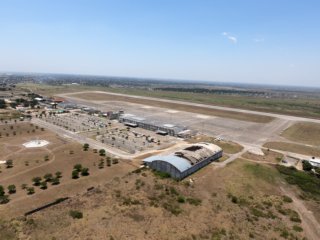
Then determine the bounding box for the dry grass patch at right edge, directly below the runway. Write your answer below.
[282,122,320,146]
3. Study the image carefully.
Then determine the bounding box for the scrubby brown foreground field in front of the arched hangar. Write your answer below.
[0,159,316,240]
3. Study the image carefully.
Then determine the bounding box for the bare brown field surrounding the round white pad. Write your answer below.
[0,122,135,218]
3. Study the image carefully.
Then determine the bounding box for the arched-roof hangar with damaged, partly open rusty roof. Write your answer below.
[143,142,223,180]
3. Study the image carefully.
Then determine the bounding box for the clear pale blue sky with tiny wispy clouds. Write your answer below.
[0,0,320,87]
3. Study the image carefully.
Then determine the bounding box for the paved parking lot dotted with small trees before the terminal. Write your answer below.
[42,111,177,154]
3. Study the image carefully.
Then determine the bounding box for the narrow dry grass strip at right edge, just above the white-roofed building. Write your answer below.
[263,142,320,157]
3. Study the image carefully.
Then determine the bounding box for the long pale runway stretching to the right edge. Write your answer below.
[57,91,320,123]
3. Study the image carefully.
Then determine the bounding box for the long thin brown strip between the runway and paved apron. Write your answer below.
[70,92,273,123]
